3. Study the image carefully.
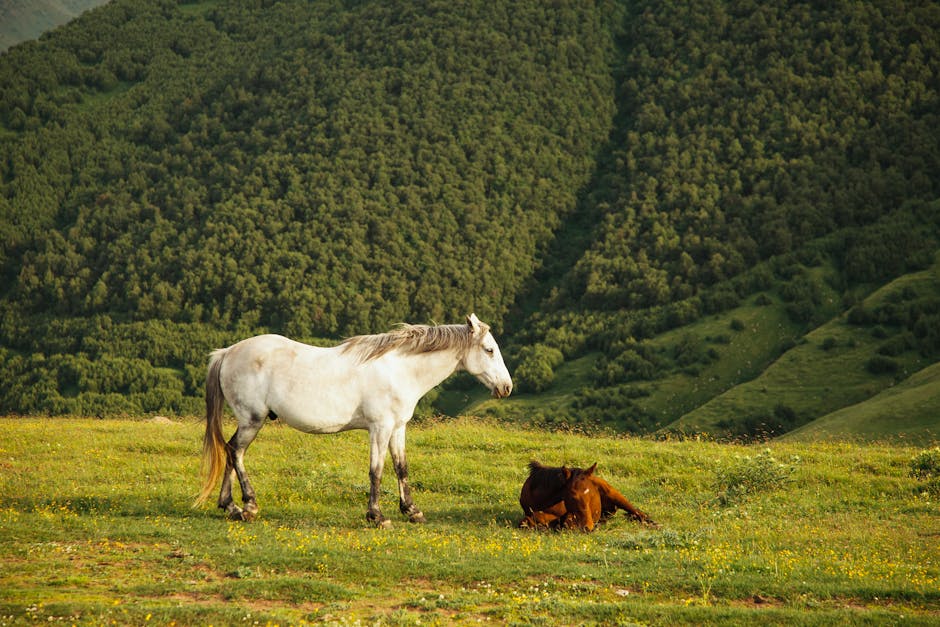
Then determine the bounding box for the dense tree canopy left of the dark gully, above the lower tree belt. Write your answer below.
[0,2,612,335]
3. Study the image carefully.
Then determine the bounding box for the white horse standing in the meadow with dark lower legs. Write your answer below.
[196,314,512,527]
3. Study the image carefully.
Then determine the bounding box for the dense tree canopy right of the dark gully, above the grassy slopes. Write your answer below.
[544,1,940,309]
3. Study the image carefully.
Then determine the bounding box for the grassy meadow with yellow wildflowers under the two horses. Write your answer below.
[0,418,940,625]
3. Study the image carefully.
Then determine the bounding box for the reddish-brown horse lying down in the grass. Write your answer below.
[519,461,658,531]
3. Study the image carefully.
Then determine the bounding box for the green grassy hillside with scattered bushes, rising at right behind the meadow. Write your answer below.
[670,253,940,444]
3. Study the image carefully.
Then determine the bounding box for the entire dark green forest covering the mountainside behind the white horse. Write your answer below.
[0,0,940,442]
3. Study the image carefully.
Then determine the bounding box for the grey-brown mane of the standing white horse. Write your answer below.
[340,323,489,362]
